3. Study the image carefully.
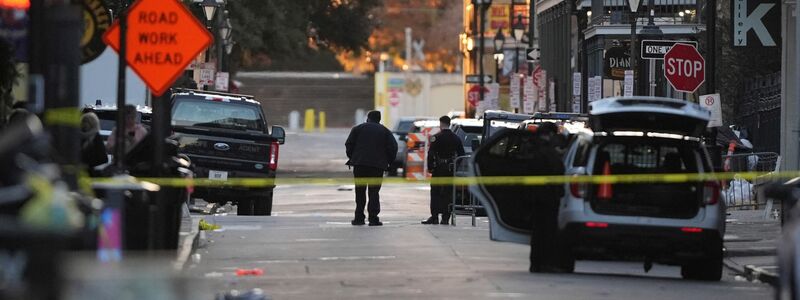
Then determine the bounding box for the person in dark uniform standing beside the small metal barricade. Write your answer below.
[422,116,464,225]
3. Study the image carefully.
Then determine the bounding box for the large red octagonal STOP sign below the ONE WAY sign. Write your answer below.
[664,44,706,93]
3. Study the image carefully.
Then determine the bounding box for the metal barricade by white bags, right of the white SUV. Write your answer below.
[722,152,780,210]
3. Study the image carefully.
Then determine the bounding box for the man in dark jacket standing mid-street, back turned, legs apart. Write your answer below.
[344,110,397,226]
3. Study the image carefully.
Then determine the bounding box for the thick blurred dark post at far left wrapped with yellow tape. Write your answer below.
[30,0,83,190]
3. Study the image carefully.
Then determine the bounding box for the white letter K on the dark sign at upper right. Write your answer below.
[733,0,776,47]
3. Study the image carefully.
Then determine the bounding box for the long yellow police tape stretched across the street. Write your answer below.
[89,171,800,188]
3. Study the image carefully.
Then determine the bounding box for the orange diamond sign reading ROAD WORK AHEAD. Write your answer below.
[103,0,213,96]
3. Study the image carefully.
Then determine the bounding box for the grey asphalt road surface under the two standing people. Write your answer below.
[187,131,772,299]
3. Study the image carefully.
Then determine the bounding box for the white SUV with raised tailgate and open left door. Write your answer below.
[470,97,725,281]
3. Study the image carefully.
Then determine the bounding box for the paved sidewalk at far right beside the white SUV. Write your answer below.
[724,210,781,284]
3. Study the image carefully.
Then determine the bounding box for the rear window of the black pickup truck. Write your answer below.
[172,98,264,131]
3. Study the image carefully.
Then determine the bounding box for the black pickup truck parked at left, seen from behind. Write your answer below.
[172,89,286,215]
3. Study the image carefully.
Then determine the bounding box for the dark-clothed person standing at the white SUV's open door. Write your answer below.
[528,122,574,272]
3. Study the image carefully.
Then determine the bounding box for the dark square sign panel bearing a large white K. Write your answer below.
[731,0,781,47]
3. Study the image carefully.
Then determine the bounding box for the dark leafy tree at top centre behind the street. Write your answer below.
[222,0,380,70]
